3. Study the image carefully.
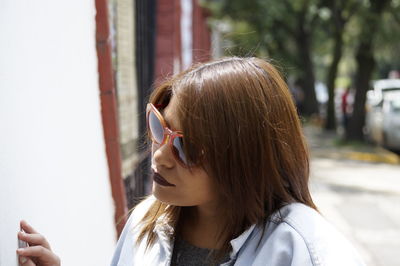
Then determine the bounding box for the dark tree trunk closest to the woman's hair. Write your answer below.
[297,30,319,115]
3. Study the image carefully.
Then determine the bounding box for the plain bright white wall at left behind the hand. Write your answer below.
[0,0,116,266]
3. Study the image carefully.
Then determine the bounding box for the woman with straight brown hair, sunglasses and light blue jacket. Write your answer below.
[20,57,363,266]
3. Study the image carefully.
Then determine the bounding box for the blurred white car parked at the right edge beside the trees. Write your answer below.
[365,79,400,151]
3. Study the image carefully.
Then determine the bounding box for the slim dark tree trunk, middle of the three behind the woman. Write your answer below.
[325,29,343,130]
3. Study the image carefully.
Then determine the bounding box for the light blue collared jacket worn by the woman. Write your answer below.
[111,197,364,266]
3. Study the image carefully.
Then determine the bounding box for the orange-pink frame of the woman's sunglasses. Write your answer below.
[146,103,188,168]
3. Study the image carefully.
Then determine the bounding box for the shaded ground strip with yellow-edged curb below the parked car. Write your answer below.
[303,124,400,165]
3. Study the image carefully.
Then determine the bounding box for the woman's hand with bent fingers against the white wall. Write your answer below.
[17,221,60,266]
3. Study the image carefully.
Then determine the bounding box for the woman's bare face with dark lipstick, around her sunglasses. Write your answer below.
[151,96,217,206]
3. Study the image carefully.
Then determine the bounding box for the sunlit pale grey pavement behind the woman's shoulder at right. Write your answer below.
[310,148,400,266]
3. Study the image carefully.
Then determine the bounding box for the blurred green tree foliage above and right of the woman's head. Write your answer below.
[206,0,400,79]
